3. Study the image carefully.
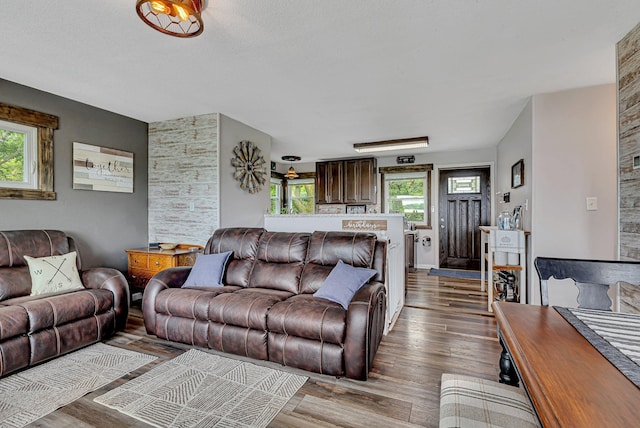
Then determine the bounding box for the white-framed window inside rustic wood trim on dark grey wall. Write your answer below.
[0,120,38,189]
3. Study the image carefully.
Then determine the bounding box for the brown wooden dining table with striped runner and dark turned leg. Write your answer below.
[493,302,640,428]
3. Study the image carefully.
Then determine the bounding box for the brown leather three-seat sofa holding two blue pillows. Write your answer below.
[142,228,386,380]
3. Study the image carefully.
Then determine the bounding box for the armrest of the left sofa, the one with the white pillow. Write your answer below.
[82,267,129,330]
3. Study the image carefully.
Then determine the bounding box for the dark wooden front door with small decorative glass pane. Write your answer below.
[438,168,491,270]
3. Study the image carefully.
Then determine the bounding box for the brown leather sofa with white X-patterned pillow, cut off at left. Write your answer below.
[0,230,129,376]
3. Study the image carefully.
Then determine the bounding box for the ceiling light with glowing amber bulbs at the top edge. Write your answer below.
[136,0,205,37]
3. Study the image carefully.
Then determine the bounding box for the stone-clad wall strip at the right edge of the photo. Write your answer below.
[617,24,640,260]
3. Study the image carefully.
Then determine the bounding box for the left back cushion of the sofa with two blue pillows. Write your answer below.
[205,227,264,287]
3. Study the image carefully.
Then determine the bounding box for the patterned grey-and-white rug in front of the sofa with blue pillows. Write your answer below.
[94,349,307,427]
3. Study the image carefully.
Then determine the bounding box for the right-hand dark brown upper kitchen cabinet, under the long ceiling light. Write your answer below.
[344,158,377,204]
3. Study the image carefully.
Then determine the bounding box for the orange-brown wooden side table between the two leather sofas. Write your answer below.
[125,244,204,289]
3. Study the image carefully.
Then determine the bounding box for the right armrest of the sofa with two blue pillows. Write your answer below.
[344,282,387,380]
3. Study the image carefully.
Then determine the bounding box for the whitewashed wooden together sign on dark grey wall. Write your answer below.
[73,142,133,193]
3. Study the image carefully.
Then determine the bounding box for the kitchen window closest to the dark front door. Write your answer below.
[384,171,429,225]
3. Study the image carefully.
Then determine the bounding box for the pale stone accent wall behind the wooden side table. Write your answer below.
[149,113,220,245]
